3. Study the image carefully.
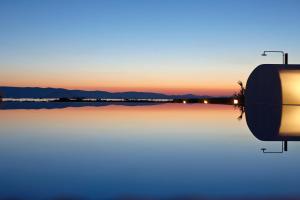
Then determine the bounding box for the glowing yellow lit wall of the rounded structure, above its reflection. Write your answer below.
[279,70,300,105]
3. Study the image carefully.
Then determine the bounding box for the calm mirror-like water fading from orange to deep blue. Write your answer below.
[0,104,300,199]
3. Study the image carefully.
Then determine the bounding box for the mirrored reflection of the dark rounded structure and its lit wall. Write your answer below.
[245,105,300,141]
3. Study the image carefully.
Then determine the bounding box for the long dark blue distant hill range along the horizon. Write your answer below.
[0,86,208,99]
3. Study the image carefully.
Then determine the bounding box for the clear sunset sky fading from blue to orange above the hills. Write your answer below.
[0,0,300,96]
